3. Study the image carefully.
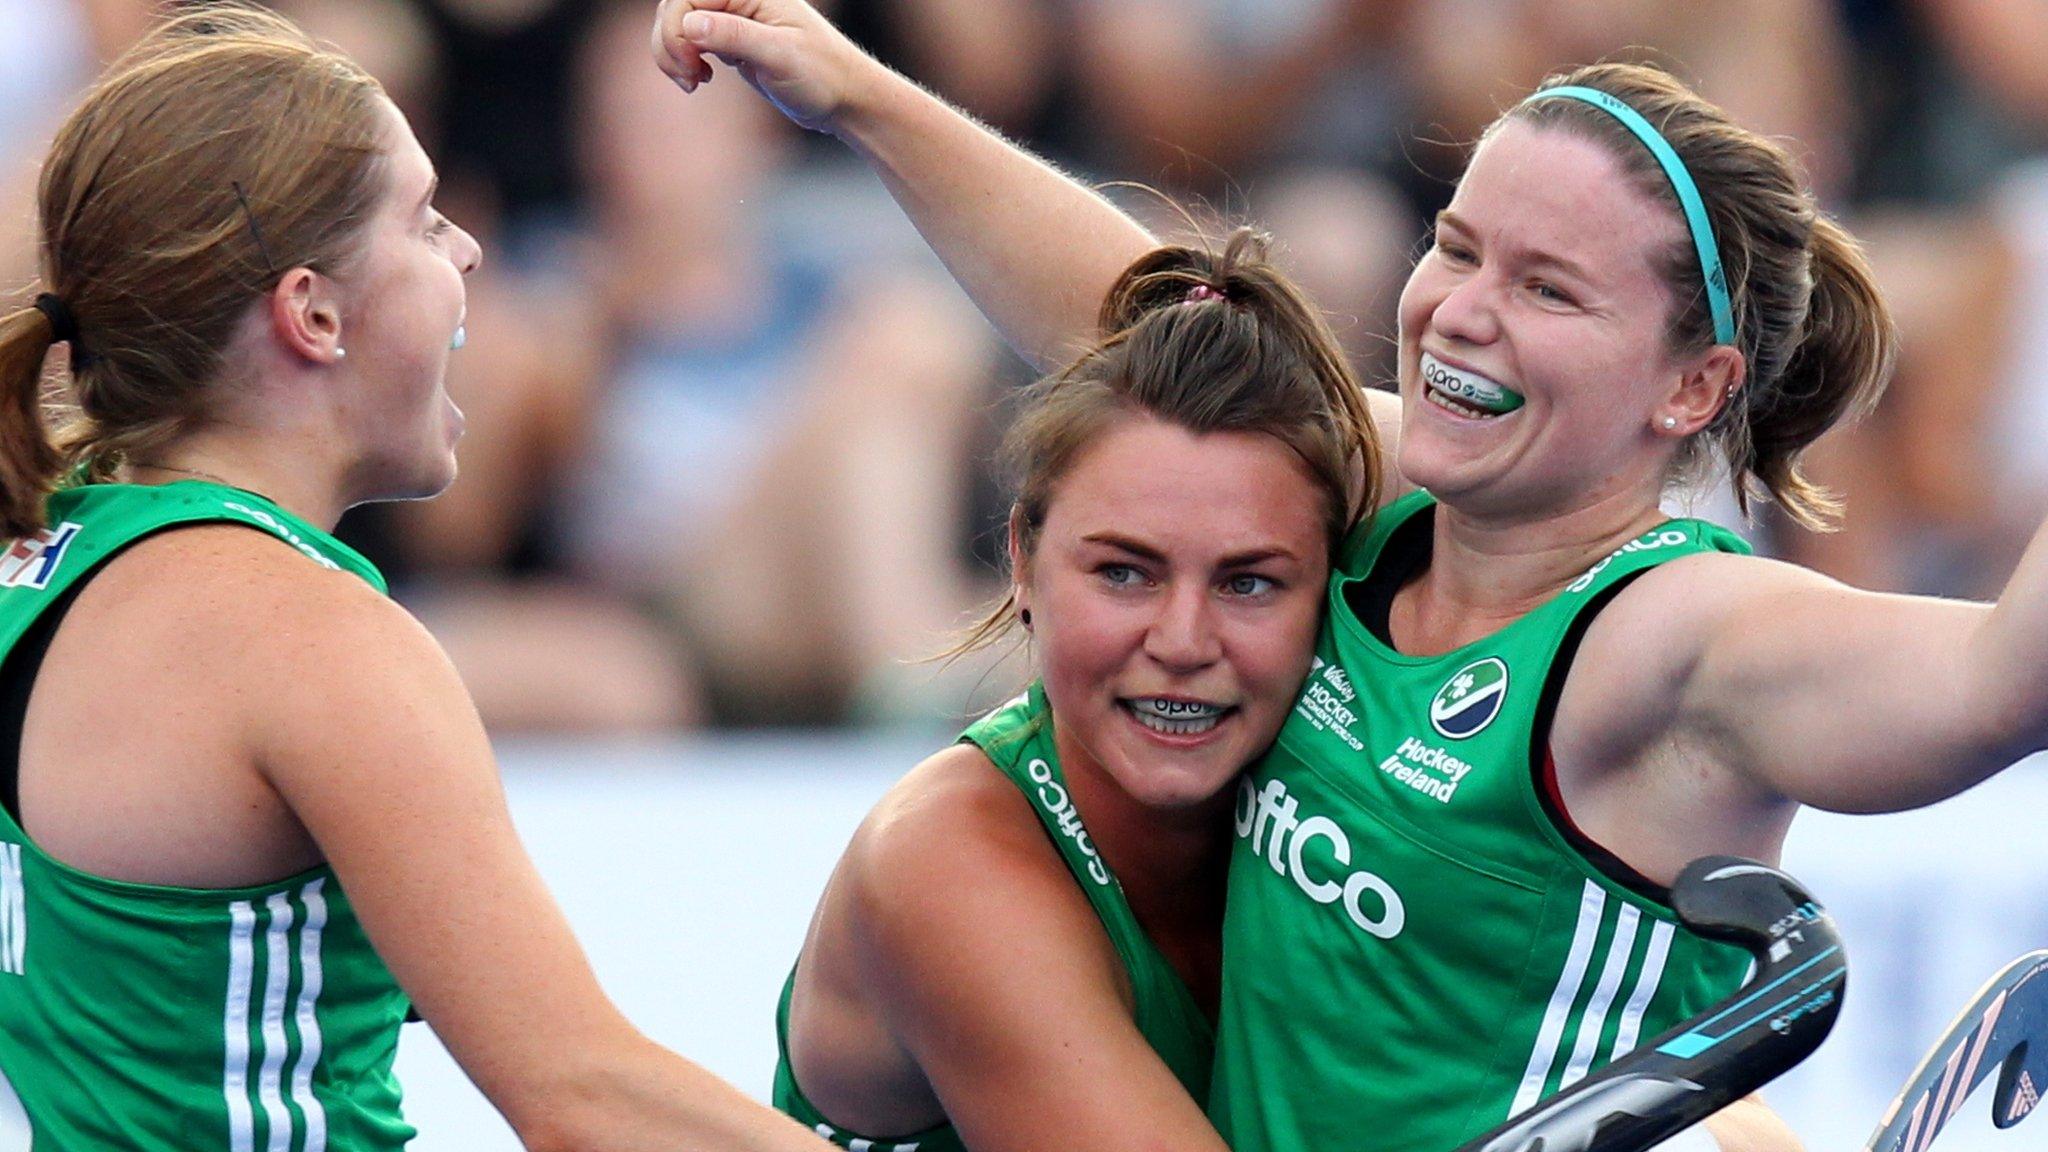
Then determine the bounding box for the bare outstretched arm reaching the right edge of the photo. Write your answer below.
[1559,539,2048,812]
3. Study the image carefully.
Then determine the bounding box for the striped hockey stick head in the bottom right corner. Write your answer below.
[1864,951,2048,1152]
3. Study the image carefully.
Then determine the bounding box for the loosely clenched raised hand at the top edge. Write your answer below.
[653,0,885,131]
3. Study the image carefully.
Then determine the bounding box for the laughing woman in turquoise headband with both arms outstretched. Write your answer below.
[653,0,1982,1152]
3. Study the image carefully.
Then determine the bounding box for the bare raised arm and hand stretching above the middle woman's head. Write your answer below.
[653,0,1155,369]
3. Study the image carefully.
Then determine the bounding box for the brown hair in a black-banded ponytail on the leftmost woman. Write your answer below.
[0,0,395,535]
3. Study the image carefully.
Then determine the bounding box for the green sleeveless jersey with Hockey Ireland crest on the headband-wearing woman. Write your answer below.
[1210,492,1749,1152]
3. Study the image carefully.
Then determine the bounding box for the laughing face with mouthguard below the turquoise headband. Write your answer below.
[1399,121,1686,515]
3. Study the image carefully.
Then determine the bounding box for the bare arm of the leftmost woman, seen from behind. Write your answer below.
[243,539,825,1152]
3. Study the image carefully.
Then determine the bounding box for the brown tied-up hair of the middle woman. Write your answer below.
[950,228,1380,656]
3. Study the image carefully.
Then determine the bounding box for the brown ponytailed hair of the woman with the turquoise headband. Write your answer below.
[1489,64,1898,529]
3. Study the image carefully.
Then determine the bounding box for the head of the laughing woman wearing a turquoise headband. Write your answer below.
[1401,66,1892,527]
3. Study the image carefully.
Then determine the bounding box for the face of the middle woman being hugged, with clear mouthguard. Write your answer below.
[1018,416,1329,808]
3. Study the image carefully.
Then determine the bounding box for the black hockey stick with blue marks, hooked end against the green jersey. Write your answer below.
[1458,857,1849,1152]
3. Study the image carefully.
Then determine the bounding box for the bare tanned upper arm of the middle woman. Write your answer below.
[848,762,1225,1152]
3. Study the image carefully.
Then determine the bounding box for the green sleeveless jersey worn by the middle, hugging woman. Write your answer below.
[774,685,1214,1152]
